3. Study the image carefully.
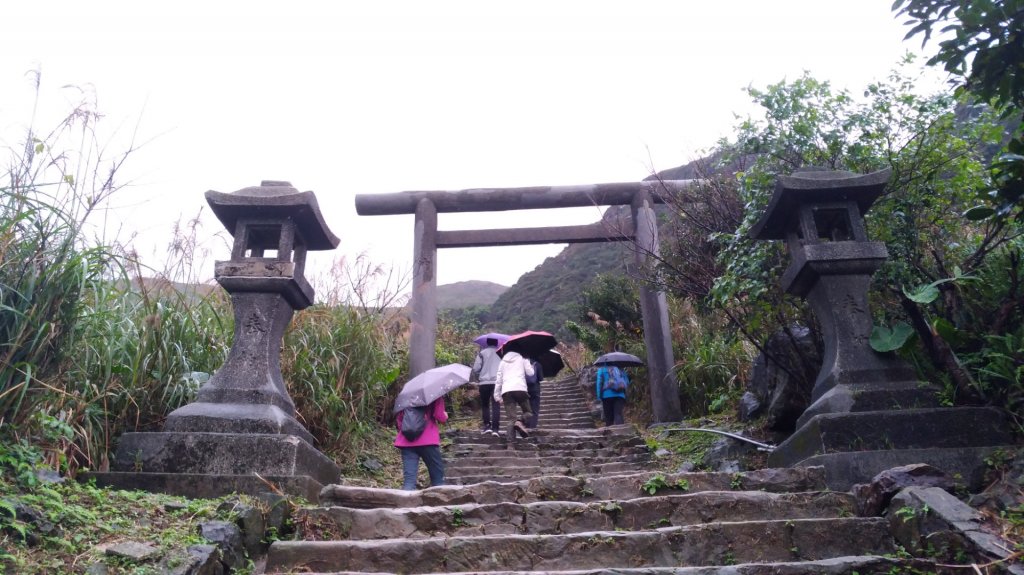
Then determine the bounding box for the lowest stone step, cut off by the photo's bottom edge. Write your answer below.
[274,556,937,575]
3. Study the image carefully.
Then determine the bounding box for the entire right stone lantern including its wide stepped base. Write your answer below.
[751,170,1012,490]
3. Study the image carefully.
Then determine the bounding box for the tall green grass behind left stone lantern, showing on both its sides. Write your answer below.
[0,89,415,473]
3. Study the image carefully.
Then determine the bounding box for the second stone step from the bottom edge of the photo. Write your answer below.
[265,518,896,573]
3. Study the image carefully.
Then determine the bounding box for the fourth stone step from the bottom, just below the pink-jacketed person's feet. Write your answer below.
[319,467,826,508]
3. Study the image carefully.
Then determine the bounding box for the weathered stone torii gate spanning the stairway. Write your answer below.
[355,180,694,422]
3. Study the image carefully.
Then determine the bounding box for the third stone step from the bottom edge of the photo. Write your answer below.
[295,491,855,540]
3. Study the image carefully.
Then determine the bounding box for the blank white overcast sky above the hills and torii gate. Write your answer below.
[0,0,942,285]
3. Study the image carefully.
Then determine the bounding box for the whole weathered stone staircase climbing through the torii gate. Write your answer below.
[265,381,936,575]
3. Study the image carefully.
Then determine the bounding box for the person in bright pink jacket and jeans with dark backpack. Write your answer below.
[394,397,447,491]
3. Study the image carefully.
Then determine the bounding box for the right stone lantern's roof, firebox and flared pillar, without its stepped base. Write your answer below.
[750,165,921,427]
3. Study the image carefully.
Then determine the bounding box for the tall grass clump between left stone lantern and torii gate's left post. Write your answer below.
[281,256,408,461]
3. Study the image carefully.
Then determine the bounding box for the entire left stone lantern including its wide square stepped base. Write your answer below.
[97,181,339,500]
